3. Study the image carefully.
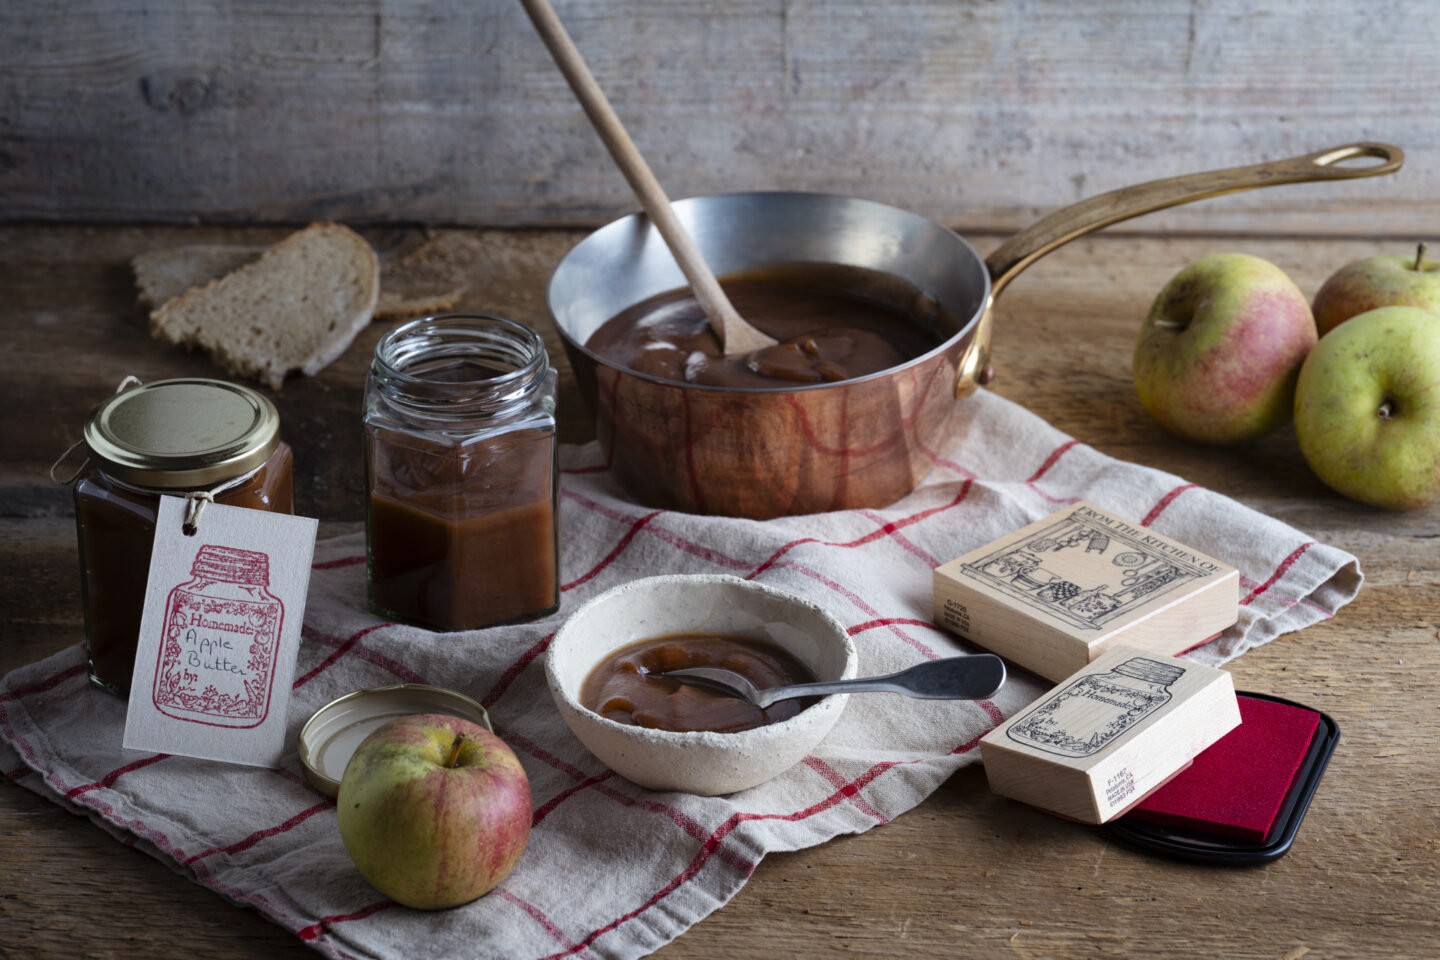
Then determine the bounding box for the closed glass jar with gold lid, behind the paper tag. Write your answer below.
[75,379,295,695]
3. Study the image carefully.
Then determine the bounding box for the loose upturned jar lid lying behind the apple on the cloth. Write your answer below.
[298,684,494,797]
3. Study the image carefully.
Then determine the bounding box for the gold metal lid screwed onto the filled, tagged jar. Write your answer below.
[85,379,279,489]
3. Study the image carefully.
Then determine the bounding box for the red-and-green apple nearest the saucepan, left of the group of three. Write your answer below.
[1133,253,1316,443]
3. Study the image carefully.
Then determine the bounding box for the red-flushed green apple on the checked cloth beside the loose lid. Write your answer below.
[336,714,531,910]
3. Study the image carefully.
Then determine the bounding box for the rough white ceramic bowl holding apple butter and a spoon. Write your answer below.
[544,576,855,796]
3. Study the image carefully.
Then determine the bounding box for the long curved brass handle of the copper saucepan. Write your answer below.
[955,142,1405,397]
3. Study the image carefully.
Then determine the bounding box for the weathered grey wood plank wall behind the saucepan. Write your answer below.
[0,0,1440,235]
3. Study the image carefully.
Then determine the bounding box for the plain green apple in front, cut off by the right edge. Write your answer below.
[1295,307,1440,510]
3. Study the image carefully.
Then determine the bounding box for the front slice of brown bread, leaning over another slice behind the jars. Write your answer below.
[150,223,380,390]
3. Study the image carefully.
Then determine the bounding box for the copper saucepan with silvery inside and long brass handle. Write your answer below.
[549,142,1404,518]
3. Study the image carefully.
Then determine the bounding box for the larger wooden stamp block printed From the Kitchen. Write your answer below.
[933,502,1240,681]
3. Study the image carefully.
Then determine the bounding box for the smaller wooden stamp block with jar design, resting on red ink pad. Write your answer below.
[981,646,1240,823]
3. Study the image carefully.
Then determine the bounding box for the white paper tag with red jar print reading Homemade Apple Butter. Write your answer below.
[124,497,318,767]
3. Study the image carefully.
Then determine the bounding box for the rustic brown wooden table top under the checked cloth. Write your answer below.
[0,225,1440,960]
